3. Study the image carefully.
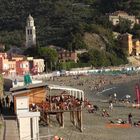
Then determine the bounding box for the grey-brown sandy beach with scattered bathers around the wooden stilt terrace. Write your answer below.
[40,74,140,140]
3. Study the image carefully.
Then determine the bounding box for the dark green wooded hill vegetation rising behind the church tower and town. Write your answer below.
[0,0,140,66]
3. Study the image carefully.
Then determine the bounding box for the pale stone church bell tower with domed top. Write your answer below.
[26,15,36,47]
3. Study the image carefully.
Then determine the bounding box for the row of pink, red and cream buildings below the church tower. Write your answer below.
[0,53,45,75]
